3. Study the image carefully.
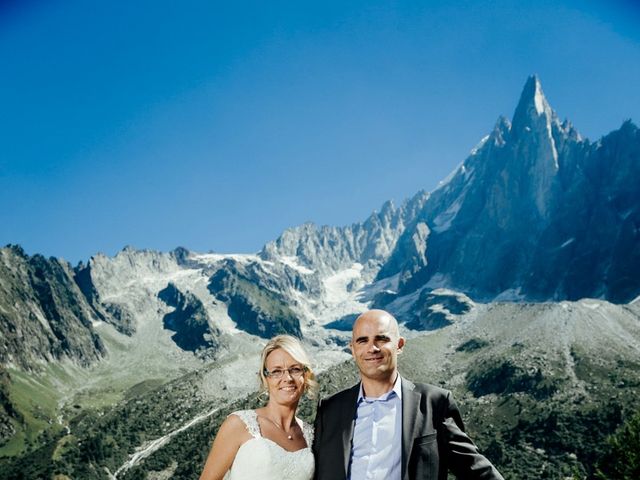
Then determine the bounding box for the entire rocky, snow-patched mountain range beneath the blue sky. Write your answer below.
[0,76,640,478]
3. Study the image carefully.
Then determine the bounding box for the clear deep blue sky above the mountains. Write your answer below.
[0,0,640,264]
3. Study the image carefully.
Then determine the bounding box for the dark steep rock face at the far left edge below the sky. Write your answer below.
[0,246,105,369]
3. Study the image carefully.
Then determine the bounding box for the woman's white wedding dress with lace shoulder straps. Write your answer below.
[224,410,315,480]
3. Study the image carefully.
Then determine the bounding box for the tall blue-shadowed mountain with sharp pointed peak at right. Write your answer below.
[378,77,640,303]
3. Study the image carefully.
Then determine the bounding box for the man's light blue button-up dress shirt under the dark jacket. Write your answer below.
[349,375,402,480]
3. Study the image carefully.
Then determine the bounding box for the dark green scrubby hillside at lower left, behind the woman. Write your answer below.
[0,362,356,480]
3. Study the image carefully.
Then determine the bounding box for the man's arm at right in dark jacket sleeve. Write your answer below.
[441,393,504,480]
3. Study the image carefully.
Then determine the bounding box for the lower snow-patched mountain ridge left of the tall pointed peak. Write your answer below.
[0,192,428,456]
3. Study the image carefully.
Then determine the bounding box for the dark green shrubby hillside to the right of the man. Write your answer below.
[456,346,640,480]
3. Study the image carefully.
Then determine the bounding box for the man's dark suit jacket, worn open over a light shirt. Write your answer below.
[313,378,503,480]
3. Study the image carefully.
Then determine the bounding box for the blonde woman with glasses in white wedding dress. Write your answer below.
[200,335,317,480]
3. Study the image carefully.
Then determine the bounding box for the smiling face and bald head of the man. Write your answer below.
[350,310,404,381]
